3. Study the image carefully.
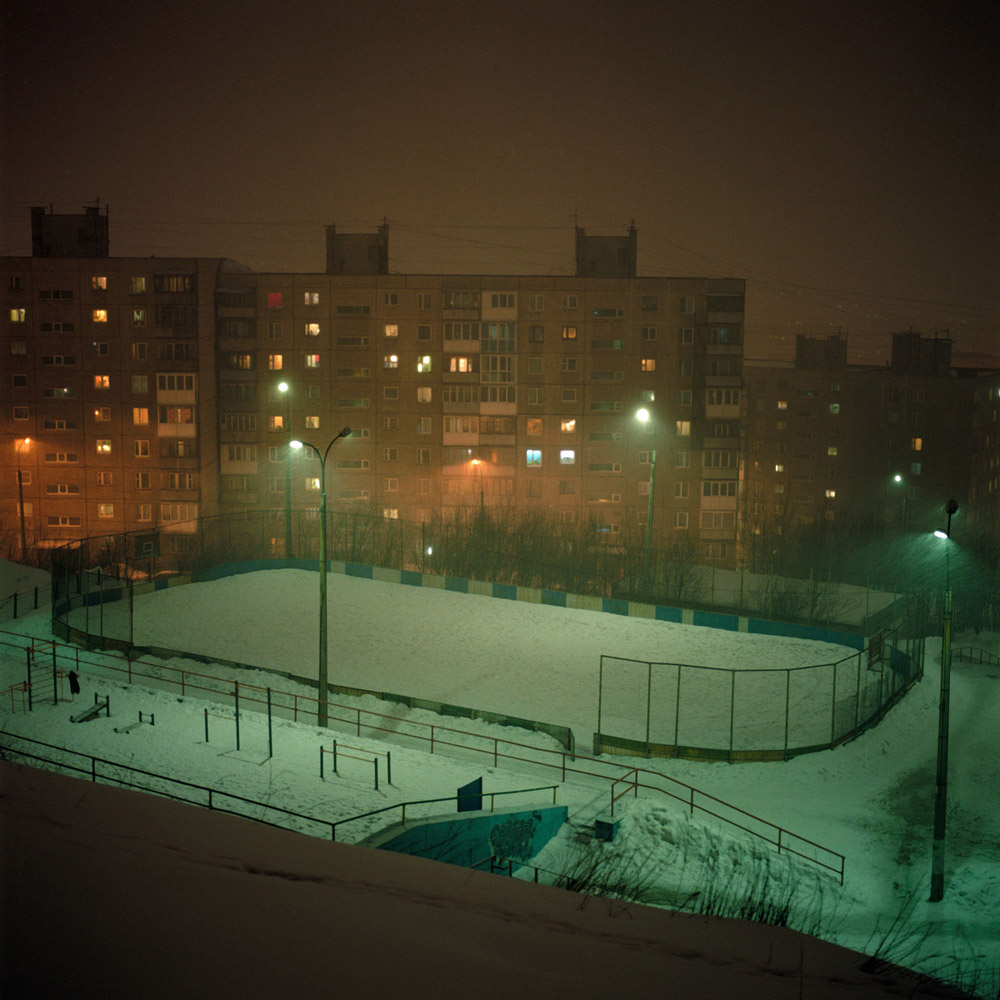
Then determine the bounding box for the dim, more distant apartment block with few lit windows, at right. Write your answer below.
[743,333,1000,532]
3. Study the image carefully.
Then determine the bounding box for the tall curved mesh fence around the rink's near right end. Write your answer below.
[594,624,925,763]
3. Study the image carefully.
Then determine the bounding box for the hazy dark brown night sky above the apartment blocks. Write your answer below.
[0,0,1000,357]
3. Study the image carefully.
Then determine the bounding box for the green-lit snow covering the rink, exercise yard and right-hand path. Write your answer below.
[0,567,1000,996]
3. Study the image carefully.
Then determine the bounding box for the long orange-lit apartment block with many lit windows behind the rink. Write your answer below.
[0,213,745,562]
